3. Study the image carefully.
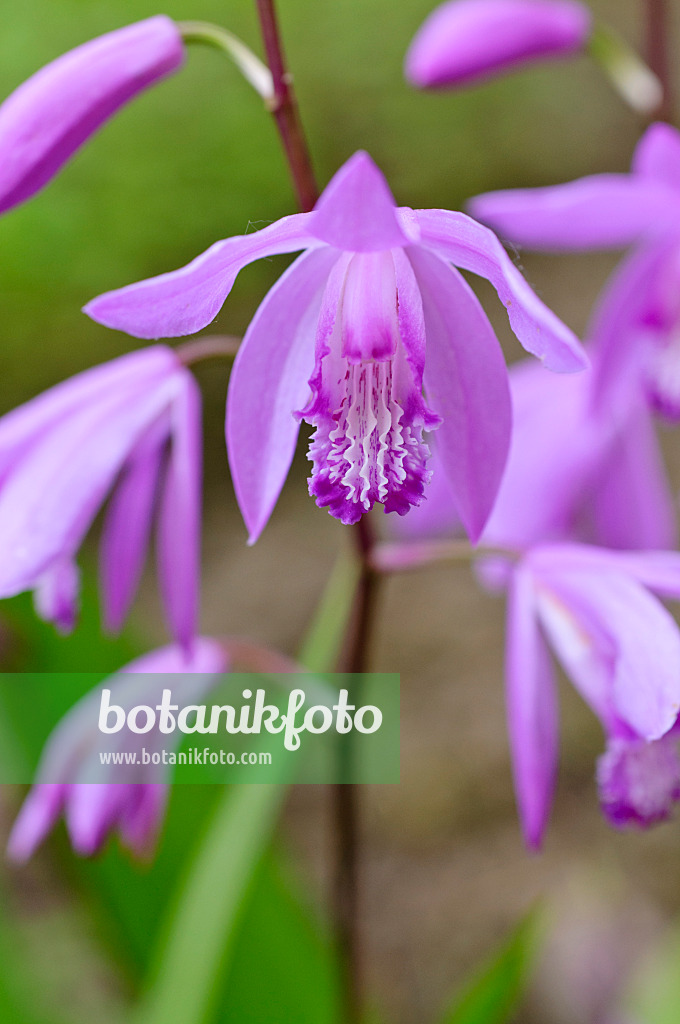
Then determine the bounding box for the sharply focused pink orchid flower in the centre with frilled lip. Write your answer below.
[86,153,586,542]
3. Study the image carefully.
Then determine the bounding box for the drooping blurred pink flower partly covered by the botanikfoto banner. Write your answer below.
[7,637,227,862]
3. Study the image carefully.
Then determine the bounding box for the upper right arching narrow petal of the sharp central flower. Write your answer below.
[416,210,588,373]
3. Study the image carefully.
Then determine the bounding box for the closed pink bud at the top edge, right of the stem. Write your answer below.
[406,0,591,88]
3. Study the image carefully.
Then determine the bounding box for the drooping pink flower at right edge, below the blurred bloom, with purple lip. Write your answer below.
[506,545,680,848]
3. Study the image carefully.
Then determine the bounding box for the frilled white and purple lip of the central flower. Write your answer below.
[301,246,436,524]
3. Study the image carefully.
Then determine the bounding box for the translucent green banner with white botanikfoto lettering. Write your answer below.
[0,673,399,784]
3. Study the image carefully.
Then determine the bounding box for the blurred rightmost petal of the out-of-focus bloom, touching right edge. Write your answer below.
[592,406,677,549]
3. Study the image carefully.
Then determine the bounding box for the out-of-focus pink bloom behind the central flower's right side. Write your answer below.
[392,354,676,550]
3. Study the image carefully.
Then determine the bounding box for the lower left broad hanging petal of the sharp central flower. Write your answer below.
[226,249,339,544]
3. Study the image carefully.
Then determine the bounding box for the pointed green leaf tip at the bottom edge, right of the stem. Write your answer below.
[441,911,540,1024]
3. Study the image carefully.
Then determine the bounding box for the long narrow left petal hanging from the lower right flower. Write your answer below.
[506,567,557,850]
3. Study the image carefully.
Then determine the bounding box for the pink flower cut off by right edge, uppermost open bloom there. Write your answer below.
[471,124,680,422]
